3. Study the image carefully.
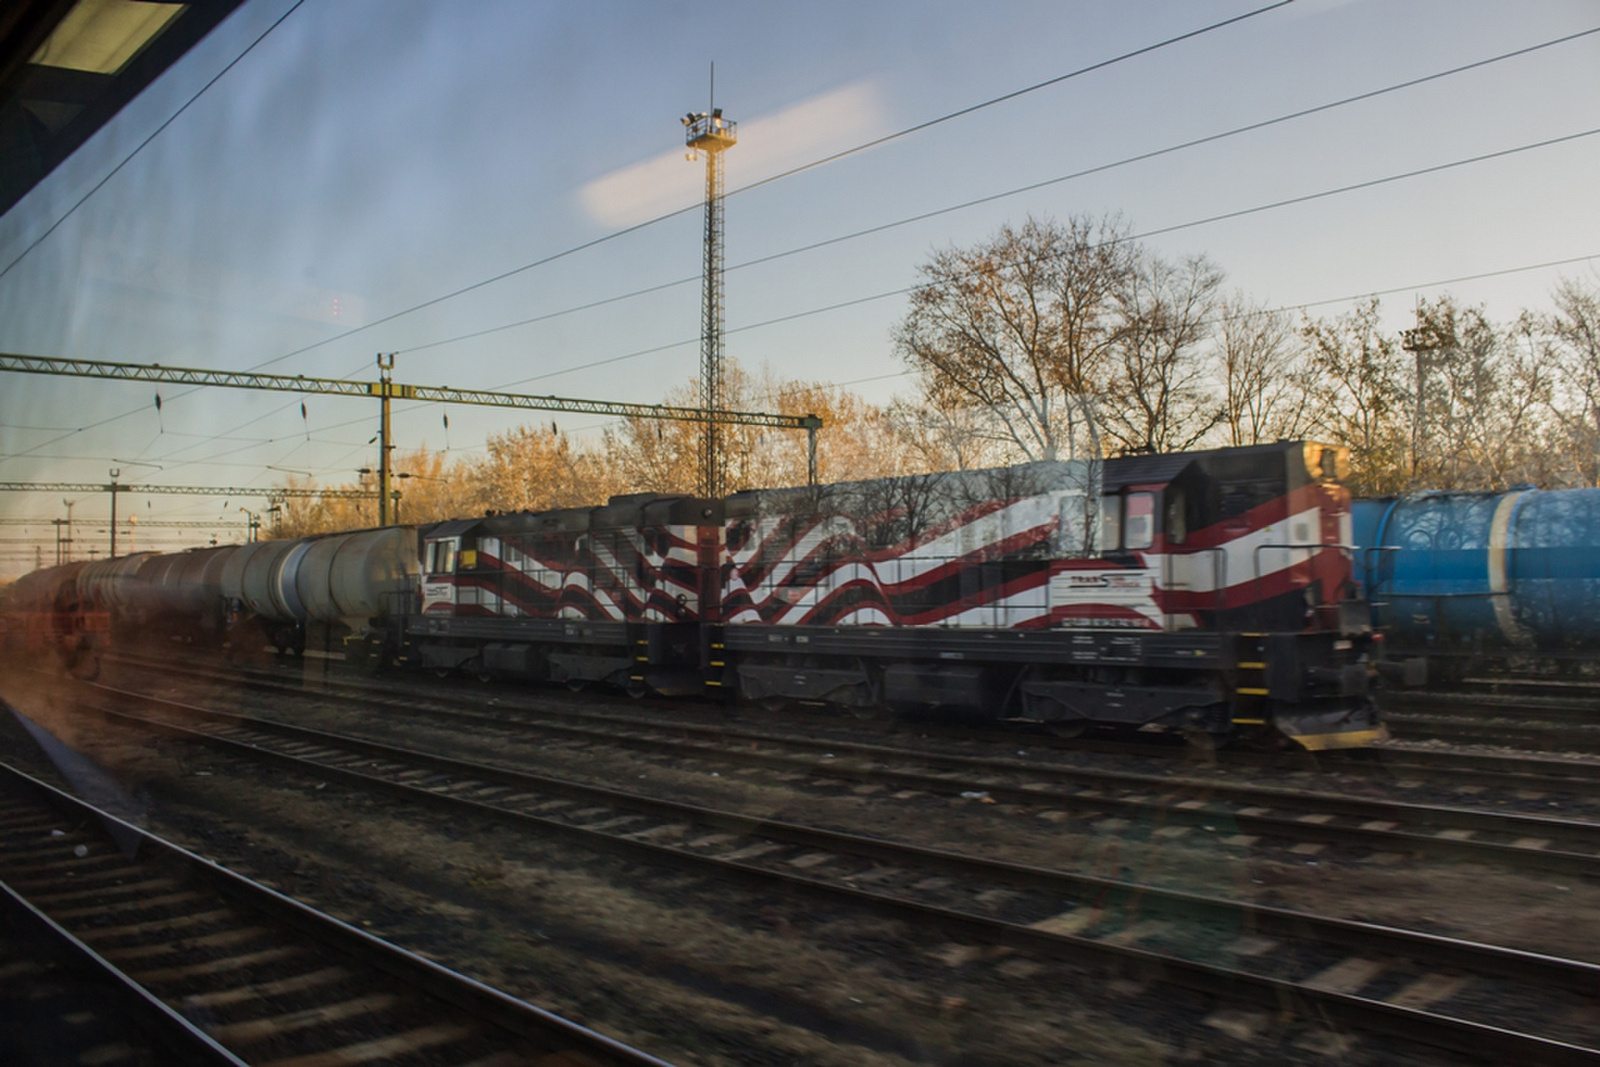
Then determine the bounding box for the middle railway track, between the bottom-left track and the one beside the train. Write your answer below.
[28,671,1600,1064]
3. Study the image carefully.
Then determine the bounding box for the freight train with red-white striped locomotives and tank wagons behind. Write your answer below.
[0,442,1382,749]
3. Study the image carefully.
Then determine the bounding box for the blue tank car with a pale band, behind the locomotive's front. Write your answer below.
[1350,490,1600,673]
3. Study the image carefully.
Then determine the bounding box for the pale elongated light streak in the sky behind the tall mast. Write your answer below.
[578,82,885,226]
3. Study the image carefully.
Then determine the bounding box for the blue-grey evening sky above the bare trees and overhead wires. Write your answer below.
[0,0,1600,576]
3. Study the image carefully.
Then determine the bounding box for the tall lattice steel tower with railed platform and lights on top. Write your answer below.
[683,85,739,498]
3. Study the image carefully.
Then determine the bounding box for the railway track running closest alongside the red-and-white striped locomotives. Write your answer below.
[96,659,1600,875]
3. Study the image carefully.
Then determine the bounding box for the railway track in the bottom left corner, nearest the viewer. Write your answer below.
[0,763,664,1067]
